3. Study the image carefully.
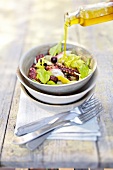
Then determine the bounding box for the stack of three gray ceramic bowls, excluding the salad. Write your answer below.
[17,43,97,112]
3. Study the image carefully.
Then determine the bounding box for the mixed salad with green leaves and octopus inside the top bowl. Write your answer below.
[28,42,92,85]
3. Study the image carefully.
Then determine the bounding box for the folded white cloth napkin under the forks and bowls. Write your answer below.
[14,90,101,141]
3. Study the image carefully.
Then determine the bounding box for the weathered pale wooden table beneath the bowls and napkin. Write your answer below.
[0,0,113,169]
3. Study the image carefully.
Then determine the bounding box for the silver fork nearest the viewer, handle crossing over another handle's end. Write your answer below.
[13,97,102,145]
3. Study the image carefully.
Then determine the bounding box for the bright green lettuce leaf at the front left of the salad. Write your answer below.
[37,68,52,84]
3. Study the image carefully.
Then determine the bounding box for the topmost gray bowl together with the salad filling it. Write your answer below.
[19,42,97,95]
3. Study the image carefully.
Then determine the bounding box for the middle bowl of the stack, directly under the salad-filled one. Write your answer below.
[17,69,98,104]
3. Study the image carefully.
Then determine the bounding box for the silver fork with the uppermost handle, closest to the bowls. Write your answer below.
[16,96,98,136]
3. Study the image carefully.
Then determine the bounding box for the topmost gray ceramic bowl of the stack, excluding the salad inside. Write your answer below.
[19,43,97,95]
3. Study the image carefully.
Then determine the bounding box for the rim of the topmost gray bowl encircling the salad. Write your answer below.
[19,43,97,88]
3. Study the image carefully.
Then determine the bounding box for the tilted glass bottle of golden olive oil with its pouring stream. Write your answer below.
[64,2,113,56]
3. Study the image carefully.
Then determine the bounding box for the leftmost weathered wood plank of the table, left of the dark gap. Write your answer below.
[0,0,32,161]
